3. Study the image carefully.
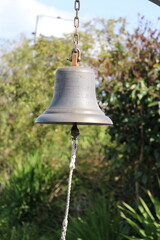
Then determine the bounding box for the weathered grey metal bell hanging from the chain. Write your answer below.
[36,67,113,125]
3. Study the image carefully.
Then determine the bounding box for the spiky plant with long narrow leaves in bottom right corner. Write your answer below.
[120,191,160,240]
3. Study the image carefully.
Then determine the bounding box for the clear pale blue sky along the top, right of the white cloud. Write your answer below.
[39,0,160,24]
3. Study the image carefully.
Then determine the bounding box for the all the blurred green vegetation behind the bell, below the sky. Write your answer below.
[0,17,160,240]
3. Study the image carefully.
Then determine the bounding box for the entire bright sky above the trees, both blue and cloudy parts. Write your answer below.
[0,0,160,39]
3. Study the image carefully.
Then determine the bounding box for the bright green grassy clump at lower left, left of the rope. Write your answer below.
[3,154,50,224]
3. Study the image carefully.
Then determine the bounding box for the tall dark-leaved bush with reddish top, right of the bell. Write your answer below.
[84,15,160,200]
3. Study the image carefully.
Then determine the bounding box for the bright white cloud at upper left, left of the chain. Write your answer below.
[0,0,74,39]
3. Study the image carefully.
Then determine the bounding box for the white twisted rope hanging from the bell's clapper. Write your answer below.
[60,138,78,240]
